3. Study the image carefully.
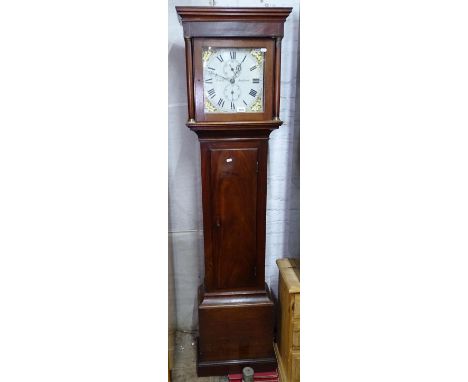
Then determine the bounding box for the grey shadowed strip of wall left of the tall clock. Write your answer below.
[167,39,204,331]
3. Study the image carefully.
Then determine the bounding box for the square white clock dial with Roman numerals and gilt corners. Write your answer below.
[202,47,266,113]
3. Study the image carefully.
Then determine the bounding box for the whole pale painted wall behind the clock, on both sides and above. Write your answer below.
[168,0,299,330]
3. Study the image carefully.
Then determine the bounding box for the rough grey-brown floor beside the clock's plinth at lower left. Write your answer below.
[171,331,228,382]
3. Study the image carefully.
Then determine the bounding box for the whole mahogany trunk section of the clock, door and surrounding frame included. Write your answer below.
[201,139,268,292]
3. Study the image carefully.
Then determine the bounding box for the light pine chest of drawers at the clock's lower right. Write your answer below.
[275,259,301,382]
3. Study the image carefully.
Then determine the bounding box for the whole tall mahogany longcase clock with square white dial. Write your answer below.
[176,7,292,376]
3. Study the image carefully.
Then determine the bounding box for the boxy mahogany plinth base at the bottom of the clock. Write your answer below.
[197,287,276,377]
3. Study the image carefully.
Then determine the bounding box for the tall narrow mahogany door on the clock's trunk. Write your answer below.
[210,148,258,289]
